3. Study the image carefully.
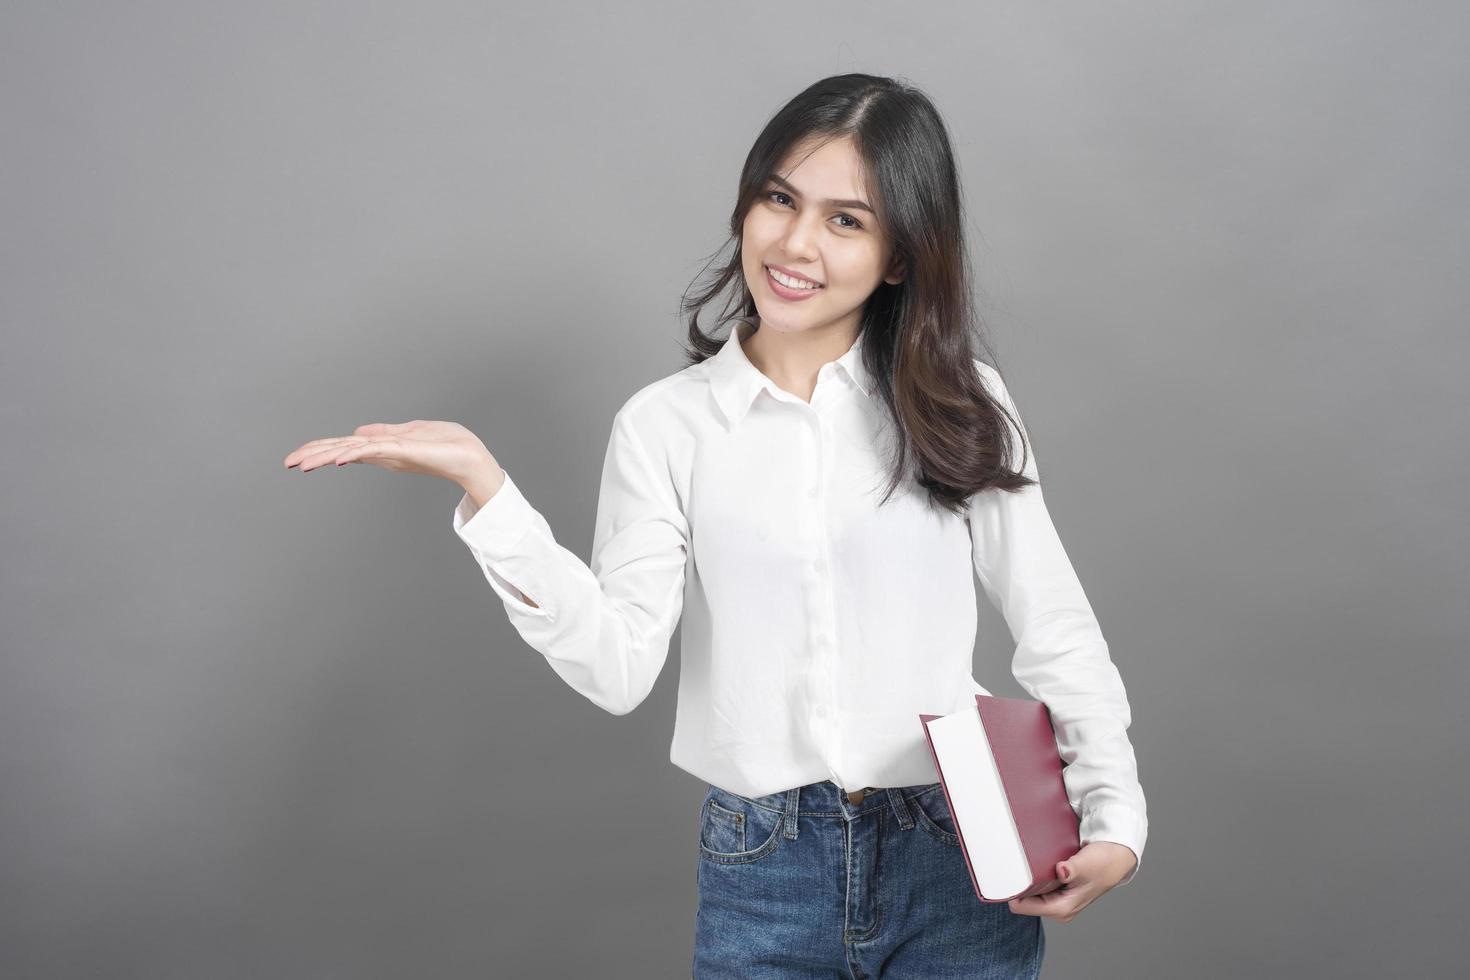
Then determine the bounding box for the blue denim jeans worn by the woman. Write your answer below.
[694,780,1047,980]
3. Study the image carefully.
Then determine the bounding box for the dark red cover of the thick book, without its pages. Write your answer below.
[919,693,1082,902]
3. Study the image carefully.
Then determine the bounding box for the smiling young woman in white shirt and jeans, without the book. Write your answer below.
[285,75,1148,980]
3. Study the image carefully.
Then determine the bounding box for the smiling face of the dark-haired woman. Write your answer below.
[741,137,903,340]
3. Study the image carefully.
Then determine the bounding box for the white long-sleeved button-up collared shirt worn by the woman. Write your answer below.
[454,323,1148,882]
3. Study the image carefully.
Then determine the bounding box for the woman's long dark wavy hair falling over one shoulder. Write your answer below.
[681,73,1035,513]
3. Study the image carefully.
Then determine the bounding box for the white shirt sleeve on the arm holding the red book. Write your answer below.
[969,361,1148,884]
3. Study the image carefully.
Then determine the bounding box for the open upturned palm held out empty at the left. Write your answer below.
[285,419,504,500]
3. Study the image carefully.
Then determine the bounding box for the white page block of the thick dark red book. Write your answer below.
[928,705,1030,898]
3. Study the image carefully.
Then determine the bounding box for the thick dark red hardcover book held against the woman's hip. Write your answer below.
[919,693,1082,902]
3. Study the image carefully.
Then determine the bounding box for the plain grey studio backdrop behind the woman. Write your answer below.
[0,1,1470,979]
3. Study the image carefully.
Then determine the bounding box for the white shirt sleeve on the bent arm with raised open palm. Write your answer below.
[454,411,689,714]
